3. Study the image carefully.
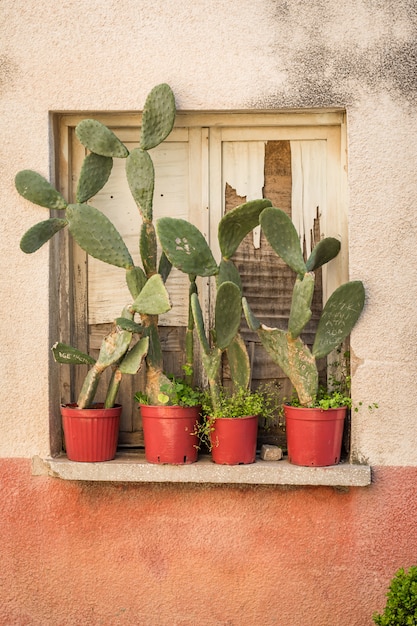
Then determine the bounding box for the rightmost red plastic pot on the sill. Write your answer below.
[284,405,346,467]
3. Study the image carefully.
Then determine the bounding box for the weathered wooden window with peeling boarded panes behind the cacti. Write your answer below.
[51,111,347,453]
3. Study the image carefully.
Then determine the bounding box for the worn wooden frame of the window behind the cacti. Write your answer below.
[50,109,348,456]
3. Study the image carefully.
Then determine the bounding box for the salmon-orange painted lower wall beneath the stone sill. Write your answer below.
[0,459,417,626]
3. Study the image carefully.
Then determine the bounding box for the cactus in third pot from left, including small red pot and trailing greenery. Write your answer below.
[156,200,271,465]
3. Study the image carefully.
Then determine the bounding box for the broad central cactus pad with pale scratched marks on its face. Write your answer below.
[156,217,218,276]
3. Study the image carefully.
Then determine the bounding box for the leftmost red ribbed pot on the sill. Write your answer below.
[61,403,122,463]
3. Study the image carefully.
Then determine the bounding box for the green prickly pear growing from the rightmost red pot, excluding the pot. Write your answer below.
[243,207,365,406]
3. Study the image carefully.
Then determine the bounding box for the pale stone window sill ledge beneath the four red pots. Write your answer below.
[32,452,372,487]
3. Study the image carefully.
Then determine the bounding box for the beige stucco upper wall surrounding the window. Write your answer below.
[0,0,417,458]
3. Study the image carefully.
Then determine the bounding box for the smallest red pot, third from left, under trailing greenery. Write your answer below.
[211,415,258,465]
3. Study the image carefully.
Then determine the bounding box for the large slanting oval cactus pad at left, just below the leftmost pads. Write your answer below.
[66,204,134,269]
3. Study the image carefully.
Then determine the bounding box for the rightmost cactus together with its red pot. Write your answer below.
[243,207,365,466]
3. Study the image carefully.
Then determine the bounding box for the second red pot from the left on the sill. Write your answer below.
[140,404,200,465]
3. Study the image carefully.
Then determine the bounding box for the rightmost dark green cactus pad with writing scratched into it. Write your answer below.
[312,280,365,359]
